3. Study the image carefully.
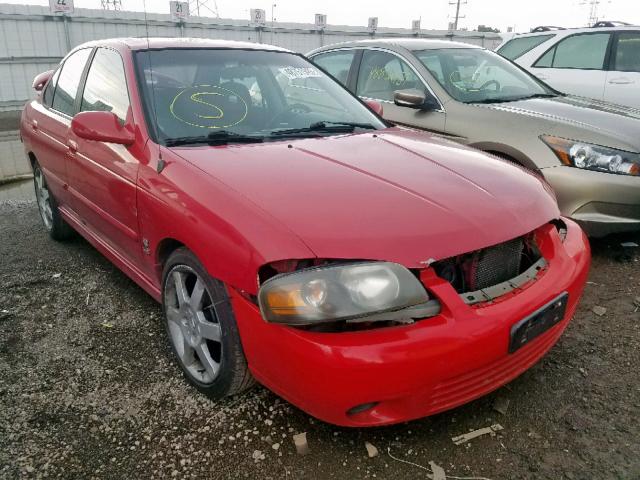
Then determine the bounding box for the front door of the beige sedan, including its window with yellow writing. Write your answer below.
[356,50,446,133]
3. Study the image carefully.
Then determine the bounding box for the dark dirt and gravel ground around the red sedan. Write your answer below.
[0,181,640,480]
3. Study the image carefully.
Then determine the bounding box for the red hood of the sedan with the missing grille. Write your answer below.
[171,128,559,267]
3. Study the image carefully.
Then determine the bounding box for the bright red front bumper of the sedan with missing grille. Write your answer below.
[231,220,590,426]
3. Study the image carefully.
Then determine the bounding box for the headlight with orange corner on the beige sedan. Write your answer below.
[540,135,640,176]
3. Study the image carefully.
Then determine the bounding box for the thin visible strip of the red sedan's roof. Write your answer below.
[71,37,291,53]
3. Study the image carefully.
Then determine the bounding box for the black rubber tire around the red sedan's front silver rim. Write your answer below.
[162,247,256,400]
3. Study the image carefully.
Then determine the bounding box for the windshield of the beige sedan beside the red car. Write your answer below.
[414,48,556,103]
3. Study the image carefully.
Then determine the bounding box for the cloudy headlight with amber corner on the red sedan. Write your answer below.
[258,262,440,325]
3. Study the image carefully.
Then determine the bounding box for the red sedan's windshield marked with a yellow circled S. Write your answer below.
[136,49,385,145]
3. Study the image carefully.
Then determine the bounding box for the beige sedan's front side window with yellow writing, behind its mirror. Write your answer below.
[356,50,424,102]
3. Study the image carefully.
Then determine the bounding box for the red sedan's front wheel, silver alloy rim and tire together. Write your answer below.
[162,248,255,399]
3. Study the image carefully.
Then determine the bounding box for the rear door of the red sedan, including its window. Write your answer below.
[28,48,91,206]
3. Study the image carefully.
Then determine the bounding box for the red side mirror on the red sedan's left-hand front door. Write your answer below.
[71,112,135,145]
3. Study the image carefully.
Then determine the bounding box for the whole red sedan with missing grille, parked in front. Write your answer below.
[21,39,590,426]
